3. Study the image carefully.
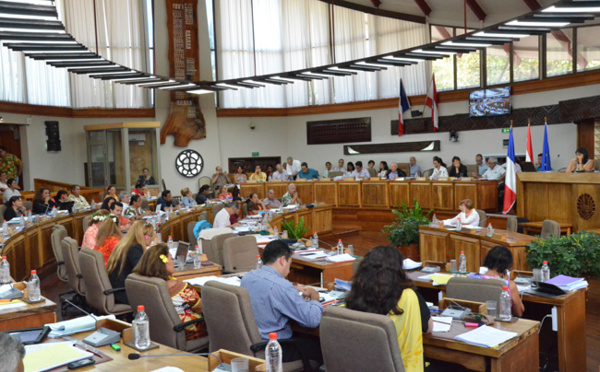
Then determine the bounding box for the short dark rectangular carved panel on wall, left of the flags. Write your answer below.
[306,118,371,145]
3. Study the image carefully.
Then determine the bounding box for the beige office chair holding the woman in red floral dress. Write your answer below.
[125,273,208,352]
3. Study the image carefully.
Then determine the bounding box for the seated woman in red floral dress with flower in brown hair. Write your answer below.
[133,243,208,340]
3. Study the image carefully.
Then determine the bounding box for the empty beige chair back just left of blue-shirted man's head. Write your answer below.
[223,236,259,273]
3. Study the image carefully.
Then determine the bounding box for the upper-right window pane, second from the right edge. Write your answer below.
[546,29,573,76]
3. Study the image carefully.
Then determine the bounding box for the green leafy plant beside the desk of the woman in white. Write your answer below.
[382,199,433,246]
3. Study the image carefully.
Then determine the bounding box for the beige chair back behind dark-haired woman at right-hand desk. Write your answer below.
[446,278,505,302]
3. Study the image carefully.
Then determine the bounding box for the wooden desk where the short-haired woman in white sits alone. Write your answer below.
[419,226,537,272]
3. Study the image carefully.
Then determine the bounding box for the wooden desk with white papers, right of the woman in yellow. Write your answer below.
[423,319,540,372]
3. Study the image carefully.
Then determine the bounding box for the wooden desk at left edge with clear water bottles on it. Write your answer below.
[0,298,57,332]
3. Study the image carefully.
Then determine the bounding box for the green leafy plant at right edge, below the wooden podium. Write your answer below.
[526,231,600,278]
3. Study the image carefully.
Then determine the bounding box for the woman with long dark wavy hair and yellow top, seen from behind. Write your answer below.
[346,246,433,372]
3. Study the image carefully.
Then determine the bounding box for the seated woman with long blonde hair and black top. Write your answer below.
[106,221,154,304]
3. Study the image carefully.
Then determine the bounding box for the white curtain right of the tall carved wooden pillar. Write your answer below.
[215,0,428,108]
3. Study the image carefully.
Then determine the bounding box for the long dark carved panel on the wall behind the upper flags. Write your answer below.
[390,105,560,136]
